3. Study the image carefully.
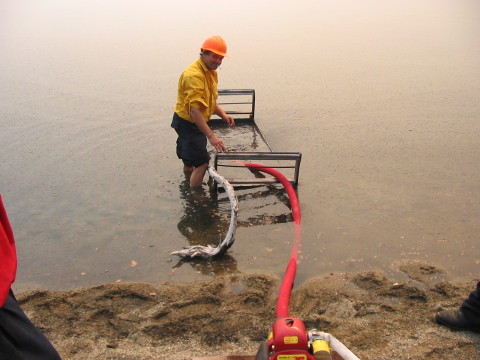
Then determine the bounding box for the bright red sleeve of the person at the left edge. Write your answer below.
[0,195,17,307]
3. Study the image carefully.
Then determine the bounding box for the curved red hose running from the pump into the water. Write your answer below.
[235,161,302,318]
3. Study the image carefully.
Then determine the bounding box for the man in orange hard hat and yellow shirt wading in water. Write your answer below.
[172,36,235,188]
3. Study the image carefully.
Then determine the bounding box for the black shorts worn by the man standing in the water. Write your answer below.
[171,113,210,167]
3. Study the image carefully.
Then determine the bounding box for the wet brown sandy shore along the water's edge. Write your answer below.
[17,262,480,360]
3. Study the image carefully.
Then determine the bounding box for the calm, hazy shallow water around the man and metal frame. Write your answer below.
[0,0,480,289]
